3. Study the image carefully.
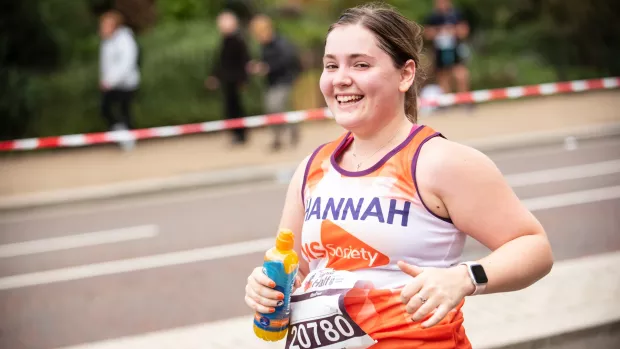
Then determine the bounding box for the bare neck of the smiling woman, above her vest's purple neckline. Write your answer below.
[352,115,412,156]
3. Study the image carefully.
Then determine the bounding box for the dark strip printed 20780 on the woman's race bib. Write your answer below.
[286,314,366,349]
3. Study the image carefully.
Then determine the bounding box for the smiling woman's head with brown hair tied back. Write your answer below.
[320,12,422,136]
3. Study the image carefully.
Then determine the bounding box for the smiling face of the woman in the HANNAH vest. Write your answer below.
[320,25,410,132]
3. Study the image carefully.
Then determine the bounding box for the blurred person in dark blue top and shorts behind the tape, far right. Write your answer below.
[424,0,469,93]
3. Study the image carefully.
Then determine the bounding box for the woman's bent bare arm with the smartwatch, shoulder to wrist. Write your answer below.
[420,138,553,293]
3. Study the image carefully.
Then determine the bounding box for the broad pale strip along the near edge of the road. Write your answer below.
[57,252,620,349]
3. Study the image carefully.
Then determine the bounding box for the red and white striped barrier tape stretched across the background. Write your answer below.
[0,77,620,151]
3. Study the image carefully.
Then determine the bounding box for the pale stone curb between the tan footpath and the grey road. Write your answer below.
[0,122,620,211]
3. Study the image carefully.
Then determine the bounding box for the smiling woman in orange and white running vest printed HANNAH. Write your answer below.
[245,1,553,349]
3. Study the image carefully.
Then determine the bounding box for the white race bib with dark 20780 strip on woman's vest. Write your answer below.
[285,269,375,349]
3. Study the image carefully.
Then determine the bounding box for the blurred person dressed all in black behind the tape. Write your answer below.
[205,12,250,144]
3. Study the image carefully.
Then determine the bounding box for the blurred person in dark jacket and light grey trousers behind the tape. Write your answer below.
[248,15,301,150]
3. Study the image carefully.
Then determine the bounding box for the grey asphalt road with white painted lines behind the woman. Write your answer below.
[0,137,620,349]
